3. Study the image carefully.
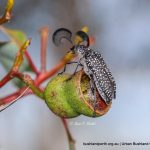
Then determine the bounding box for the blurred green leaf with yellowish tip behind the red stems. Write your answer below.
[0,26,32,87]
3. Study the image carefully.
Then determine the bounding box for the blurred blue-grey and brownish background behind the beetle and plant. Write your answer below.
[0,0,150,150]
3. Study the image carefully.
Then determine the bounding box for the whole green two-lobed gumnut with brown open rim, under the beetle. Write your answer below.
[44,70,111,118]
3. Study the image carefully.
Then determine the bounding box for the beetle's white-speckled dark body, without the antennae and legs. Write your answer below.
[74,45,116,104]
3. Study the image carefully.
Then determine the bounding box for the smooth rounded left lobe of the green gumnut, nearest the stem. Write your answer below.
[44,74,80,118]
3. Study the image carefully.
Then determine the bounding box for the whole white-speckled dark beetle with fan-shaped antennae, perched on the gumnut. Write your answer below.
[53,28,116,116]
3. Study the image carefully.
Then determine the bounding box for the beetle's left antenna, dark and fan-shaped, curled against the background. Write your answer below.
[52,28,73,46]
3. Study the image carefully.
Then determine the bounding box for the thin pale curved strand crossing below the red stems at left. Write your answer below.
[0,86,29,112]
